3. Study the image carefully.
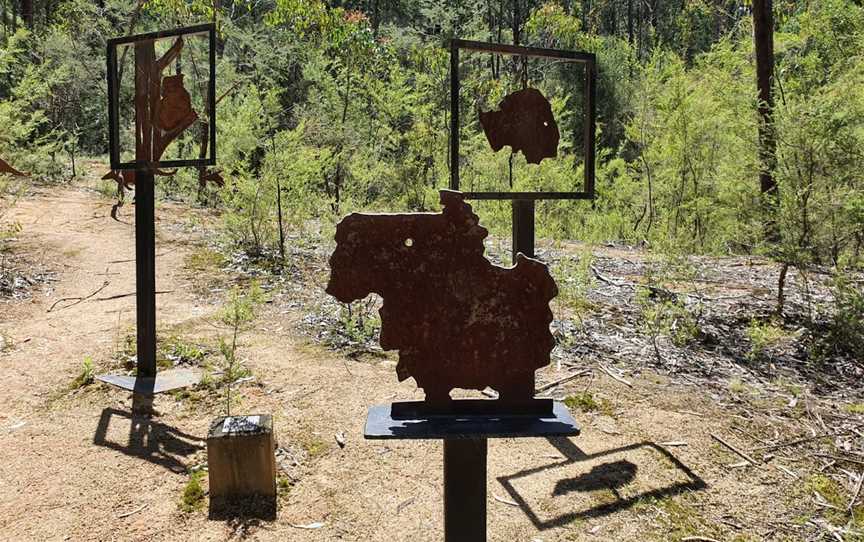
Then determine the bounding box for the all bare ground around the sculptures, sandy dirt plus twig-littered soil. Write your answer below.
[0,172,864,542]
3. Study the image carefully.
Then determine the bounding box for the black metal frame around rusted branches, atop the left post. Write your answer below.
[107,23,216,169]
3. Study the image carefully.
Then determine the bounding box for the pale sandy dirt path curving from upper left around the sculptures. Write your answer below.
[0,184,840,542]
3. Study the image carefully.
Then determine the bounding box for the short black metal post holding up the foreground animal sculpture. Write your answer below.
[444,438,486,542]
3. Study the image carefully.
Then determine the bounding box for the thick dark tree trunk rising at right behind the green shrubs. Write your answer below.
[753,0,778,242]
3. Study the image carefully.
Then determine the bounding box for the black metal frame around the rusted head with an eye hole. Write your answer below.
[450,39,597,200]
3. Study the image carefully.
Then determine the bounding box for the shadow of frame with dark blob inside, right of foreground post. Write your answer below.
[498,437,708,531]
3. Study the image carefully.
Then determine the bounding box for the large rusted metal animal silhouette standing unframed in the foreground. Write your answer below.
[327,190,558,412]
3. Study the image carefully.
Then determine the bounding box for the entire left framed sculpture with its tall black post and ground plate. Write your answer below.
[97,23,216,400]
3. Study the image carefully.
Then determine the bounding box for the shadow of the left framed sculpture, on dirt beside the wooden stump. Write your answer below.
[93,399,203,474]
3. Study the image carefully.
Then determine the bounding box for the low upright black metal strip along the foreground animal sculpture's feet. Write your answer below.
[390,399,554,420]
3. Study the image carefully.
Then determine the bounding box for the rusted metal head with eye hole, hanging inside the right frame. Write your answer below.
[480,88,561,164]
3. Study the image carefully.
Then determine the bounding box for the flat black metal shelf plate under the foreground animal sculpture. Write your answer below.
[364,401,579,439]
